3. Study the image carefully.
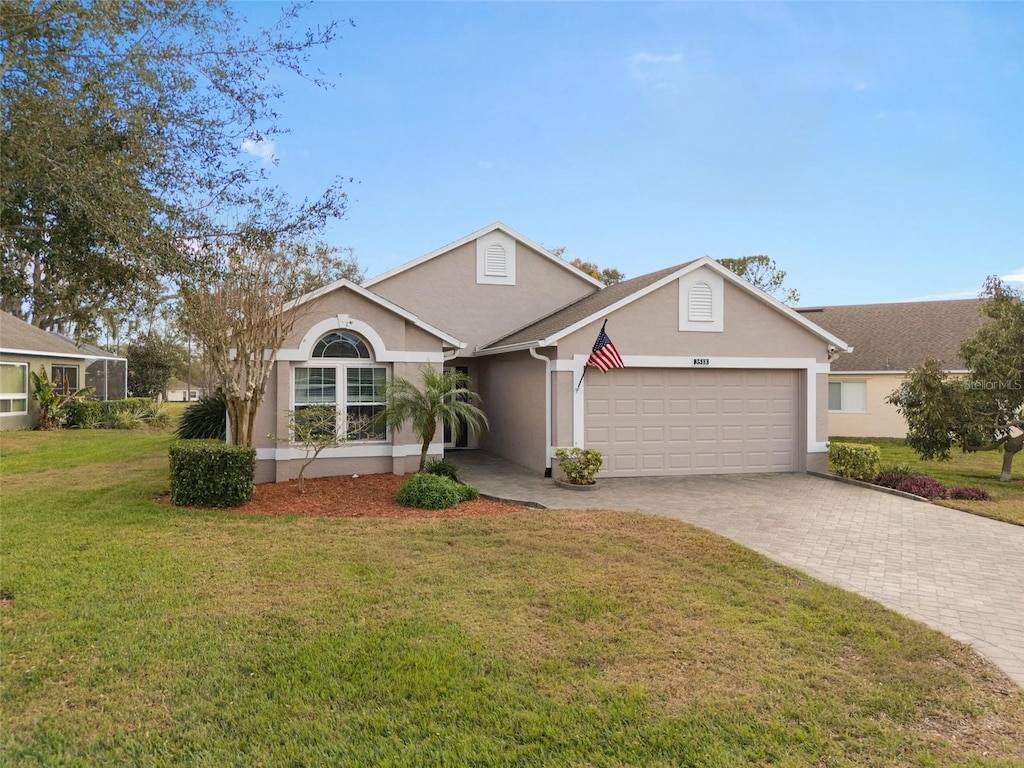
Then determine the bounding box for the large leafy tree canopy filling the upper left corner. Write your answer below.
[0,0,346,333]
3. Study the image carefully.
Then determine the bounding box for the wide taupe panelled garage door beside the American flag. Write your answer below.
[585,368,800,477]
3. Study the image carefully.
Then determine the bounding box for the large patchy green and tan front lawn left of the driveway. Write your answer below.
[6,431,1024,767]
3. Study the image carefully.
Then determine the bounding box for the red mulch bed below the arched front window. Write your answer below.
[161,475,526,518]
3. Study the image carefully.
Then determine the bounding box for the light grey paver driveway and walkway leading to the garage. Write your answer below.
[446,451,1024,687]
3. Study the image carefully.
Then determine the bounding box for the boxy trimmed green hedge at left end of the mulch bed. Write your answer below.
[170,440,256,507]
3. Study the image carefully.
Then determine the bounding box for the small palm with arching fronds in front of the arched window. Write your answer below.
[377,366,487,472]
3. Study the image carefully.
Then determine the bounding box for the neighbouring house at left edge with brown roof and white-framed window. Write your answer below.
[0,312,128,429]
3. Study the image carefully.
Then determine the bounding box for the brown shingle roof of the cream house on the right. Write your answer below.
[797,299,985,373]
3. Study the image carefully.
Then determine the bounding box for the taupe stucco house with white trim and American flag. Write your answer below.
[249,223,847,482]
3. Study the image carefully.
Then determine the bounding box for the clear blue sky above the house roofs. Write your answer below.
[237,2,1024,306]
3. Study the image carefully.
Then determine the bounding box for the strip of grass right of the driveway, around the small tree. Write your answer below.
[831,437,1024,525]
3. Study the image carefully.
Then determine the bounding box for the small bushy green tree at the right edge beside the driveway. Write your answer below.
[889,278,1024,481]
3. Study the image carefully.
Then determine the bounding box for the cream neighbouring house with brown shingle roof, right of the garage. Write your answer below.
[798,299,985,437]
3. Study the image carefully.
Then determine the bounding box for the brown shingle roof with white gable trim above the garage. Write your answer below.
[477,256,849,354]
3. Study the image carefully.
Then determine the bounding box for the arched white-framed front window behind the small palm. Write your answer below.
[293,332,387,440]
